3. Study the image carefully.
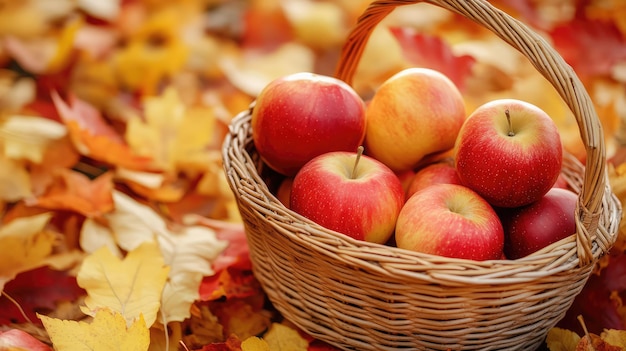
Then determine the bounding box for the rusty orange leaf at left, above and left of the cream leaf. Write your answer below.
[26,169,113,217]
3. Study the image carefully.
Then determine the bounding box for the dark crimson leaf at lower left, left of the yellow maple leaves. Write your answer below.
[0,267,85,325]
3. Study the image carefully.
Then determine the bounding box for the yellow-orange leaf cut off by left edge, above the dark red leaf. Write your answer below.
[0,213,57,291]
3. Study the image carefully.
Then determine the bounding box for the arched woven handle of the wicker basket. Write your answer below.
[335,0,607,265]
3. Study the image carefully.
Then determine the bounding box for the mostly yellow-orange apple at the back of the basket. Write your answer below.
[365,67,466,172]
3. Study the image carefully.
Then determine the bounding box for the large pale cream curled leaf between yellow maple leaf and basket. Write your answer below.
[81,192,227,322]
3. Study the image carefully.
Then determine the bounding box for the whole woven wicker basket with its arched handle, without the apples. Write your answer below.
[223,0,621,350]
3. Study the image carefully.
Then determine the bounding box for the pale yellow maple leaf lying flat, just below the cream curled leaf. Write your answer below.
[76,242,169,326]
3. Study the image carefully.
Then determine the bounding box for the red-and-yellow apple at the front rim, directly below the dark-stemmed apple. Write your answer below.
[395,183,504,261]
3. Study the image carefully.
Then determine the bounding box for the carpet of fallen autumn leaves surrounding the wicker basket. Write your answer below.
[0,0,626,351]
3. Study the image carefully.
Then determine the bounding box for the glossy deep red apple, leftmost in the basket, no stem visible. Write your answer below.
[250,72,366,176]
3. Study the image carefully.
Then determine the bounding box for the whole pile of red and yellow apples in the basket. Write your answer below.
[251,68,577,260]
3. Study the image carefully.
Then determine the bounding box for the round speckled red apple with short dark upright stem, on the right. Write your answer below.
[454,99,563,207]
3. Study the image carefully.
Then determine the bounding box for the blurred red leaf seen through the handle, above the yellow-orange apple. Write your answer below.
[390,27,476,91]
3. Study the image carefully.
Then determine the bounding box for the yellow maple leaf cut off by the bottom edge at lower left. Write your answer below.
[37,308,150,351]
